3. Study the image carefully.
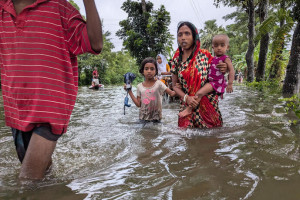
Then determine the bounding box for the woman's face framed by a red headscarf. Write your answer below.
[177,25,194,51]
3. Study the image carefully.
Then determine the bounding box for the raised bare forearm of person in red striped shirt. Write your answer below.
[83,0,103,53]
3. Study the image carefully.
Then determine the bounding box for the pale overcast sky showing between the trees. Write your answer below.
[74,0,235,51]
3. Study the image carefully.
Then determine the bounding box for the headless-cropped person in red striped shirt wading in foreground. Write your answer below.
[0,0,103,179]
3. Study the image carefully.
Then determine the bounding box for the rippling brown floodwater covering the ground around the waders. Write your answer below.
[0,86,300,200]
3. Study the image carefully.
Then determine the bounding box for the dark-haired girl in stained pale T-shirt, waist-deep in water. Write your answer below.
[124,57,176,122]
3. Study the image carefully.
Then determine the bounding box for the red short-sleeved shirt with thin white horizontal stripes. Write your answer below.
[0,0,96,135]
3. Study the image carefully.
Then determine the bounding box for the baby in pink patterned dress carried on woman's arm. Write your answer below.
[178,34,235,117]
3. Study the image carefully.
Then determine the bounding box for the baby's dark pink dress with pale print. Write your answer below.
[208,55,229,97]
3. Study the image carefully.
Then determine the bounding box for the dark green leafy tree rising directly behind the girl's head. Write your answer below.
[116,0,173,63]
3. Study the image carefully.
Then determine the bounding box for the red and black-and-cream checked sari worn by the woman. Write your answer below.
[171,23,223,128]
